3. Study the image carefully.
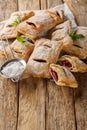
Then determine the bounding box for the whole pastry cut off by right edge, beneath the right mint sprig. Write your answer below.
[63,27,87,59]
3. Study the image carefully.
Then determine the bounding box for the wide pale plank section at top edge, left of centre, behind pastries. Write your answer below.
[18,0,40,10]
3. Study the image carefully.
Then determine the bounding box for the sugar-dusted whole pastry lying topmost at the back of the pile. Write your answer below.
[18,10,64,38]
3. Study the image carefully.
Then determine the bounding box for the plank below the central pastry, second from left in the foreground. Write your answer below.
[18,78,45,130]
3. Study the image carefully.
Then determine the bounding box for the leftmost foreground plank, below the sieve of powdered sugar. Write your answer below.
[0,77,18,130]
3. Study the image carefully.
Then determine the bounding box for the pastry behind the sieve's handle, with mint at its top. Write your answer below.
[0,36,34,61]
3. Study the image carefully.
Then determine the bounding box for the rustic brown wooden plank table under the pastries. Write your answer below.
[0,0,87,130]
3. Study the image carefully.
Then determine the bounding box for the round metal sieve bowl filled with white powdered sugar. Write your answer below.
[0,58,26,78]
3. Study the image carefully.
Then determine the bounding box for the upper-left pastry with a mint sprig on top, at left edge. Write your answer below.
[0,11,34,39]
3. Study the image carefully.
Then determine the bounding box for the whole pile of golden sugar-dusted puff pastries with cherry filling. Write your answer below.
[0,10,87,88]
